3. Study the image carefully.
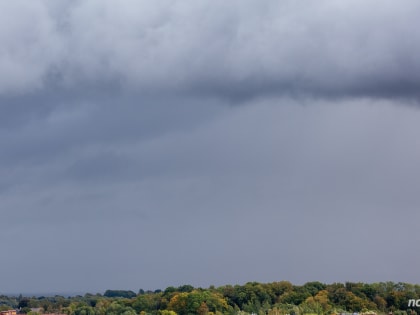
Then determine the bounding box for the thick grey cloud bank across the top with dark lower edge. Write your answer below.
[1,0,420,99]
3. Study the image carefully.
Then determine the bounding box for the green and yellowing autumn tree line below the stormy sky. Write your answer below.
[0,281,420,315]
